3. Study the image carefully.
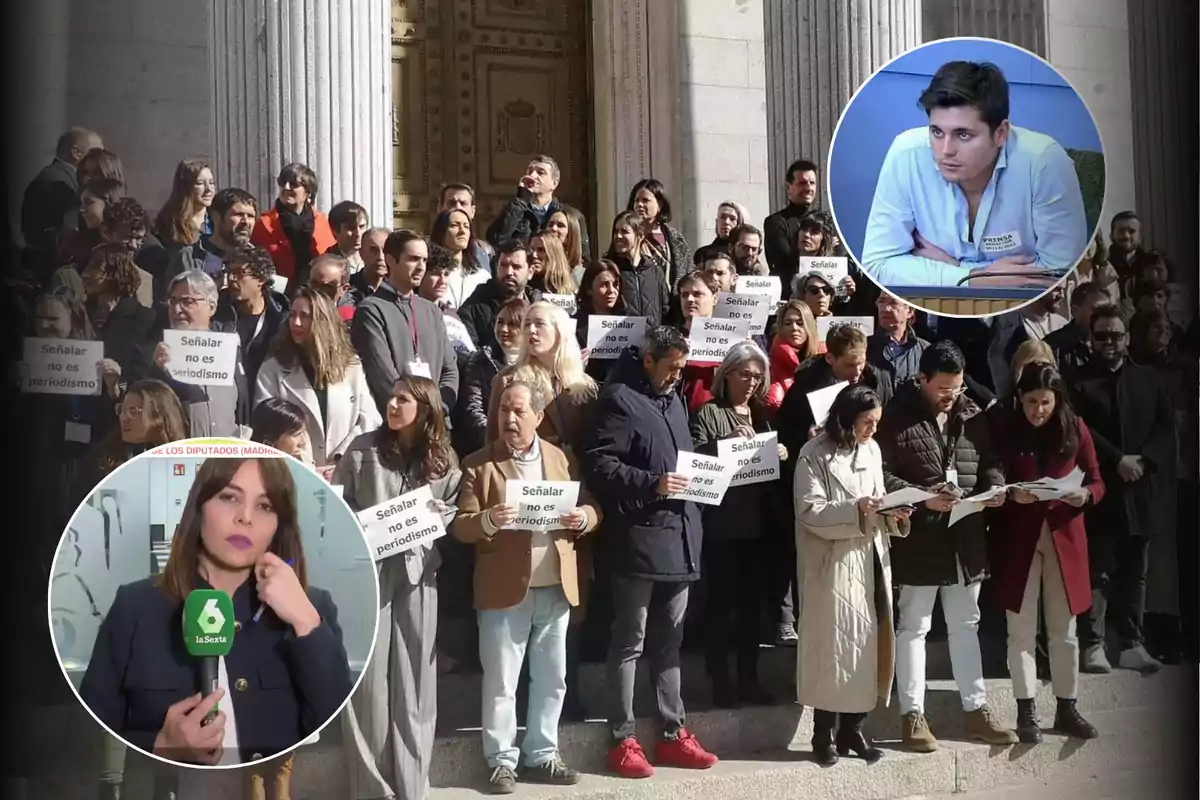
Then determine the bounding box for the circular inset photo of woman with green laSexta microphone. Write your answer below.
[49,439,379,768]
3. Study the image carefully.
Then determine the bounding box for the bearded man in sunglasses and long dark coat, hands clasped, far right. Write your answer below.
[1072,305,1176,673]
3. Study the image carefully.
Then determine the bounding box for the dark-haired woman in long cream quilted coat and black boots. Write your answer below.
[794,385,911,766]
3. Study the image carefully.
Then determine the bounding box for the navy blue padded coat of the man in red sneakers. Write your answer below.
[583,348,703,581]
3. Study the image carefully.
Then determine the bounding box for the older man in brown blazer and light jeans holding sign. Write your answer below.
[451,380,600,794]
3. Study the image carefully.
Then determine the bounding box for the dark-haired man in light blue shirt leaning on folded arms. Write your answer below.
[862,61,1091,288]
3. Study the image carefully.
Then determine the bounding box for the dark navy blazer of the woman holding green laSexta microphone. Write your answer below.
[79,578,353,763]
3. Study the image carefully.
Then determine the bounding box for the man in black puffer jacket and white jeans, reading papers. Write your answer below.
[873,341,1016,753]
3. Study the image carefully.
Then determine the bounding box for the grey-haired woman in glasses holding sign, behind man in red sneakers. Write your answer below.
[691,342,787,709]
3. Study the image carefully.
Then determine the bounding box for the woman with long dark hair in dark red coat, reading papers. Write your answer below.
[990,362,1104,744]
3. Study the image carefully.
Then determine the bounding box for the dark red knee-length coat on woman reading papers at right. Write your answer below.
[989,420,1104,614]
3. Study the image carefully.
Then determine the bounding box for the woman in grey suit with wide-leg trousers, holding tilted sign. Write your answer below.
[332,375,462,800]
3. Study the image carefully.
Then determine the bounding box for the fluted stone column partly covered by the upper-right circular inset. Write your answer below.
[764,0,922,207]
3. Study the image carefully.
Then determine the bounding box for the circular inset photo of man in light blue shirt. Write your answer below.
[827,38,1105,315]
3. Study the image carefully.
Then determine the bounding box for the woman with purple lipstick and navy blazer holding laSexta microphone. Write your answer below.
[79,458,352,765]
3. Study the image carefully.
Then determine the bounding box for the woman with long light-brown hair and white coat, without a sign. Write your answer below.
[254,287,383,471]
